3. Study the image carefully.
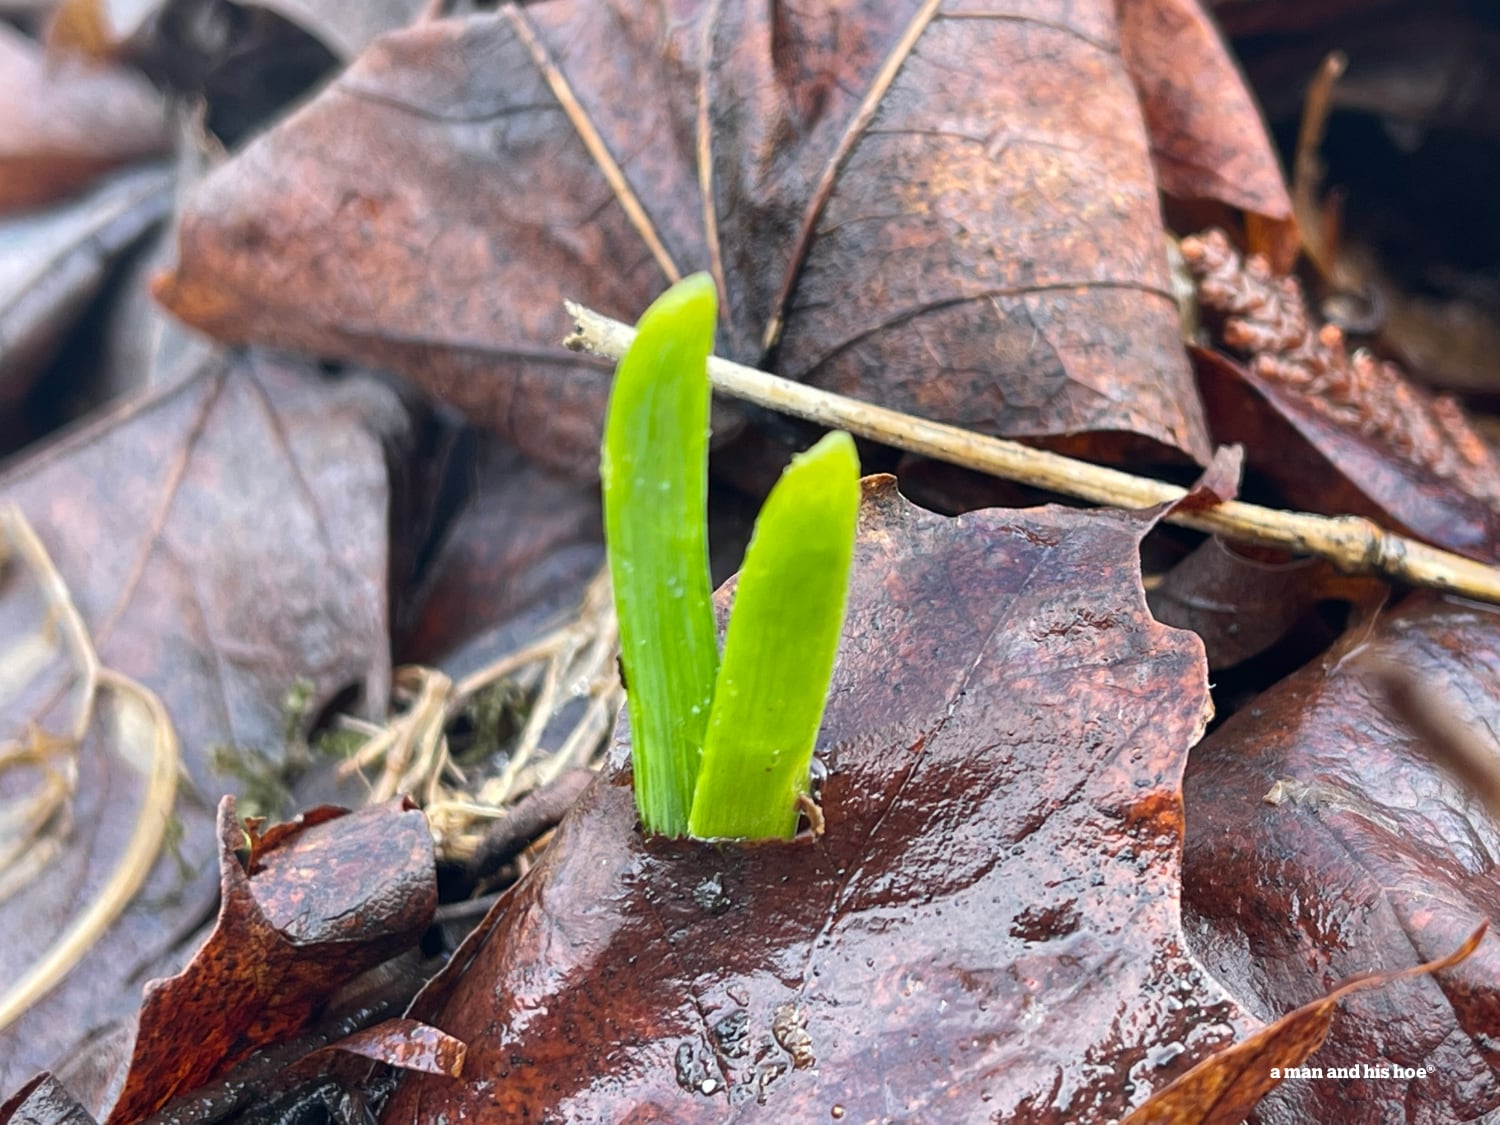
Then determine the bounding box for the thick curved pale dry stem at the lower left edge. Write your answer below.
[0,668,180,1029]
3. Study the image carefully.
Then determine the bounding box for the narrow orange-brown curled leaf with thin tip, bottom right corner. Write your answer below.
[1122,924,1487,1125]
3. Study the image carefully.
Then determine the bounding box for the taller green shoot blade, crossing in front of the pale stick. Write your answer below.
[600,273,719,836]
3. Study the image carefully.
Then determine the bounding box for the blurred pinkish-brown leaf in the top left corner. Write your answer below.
[0,24,170,212]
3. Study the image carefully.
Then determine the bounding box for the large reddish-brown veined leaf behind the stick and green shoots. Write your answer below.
[158,0,1230,474]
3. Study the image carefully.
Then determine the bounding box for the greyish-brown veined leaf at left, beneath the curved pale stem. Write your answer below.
[0,357,405,1089]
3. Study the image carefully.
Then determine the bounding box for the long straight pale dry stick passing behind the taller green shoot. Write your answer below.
[564,302,1500,605]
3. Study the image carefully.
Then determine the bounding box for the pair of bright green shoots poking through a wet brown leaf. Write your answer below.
[602,275,860,839]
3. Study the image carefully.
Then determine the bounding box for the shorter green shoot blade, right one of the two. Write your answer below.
[689,432,860,839]
